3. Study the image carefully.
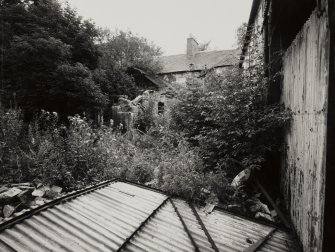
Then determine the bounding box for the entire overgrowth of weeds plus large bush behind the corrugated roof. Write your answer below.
[0,64,290,213]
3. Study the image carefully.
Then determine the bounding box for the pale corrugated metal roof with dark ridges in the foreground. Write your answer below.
[0,181,298,252]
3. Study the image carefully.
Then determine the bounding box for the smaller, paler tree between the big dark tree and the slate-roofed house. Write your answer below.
[95,30,161,104]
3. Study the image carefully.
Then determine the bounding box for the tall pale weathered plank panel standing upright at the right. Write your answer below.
[281,8,329,251]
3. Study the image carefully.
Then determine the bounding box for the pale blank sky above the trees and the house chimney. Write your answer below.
[63,0,252,55]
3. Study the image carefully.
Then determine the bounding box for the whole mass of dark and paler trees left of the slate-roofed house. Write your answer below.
[0,0,160,119]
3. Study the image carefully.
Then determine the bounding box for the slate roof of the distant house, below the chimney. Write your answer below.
[159,50,240,74]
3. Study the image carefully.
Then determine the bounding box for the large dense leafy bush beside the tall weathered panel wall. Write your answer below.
[173,68,290,178]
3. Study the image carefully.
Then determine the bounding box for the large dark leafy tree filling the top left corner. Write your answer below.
[0,0,106,119]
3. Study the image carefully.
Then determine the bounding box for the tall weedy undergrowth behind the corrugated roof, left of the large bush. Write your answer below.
[0,110,228,203]
